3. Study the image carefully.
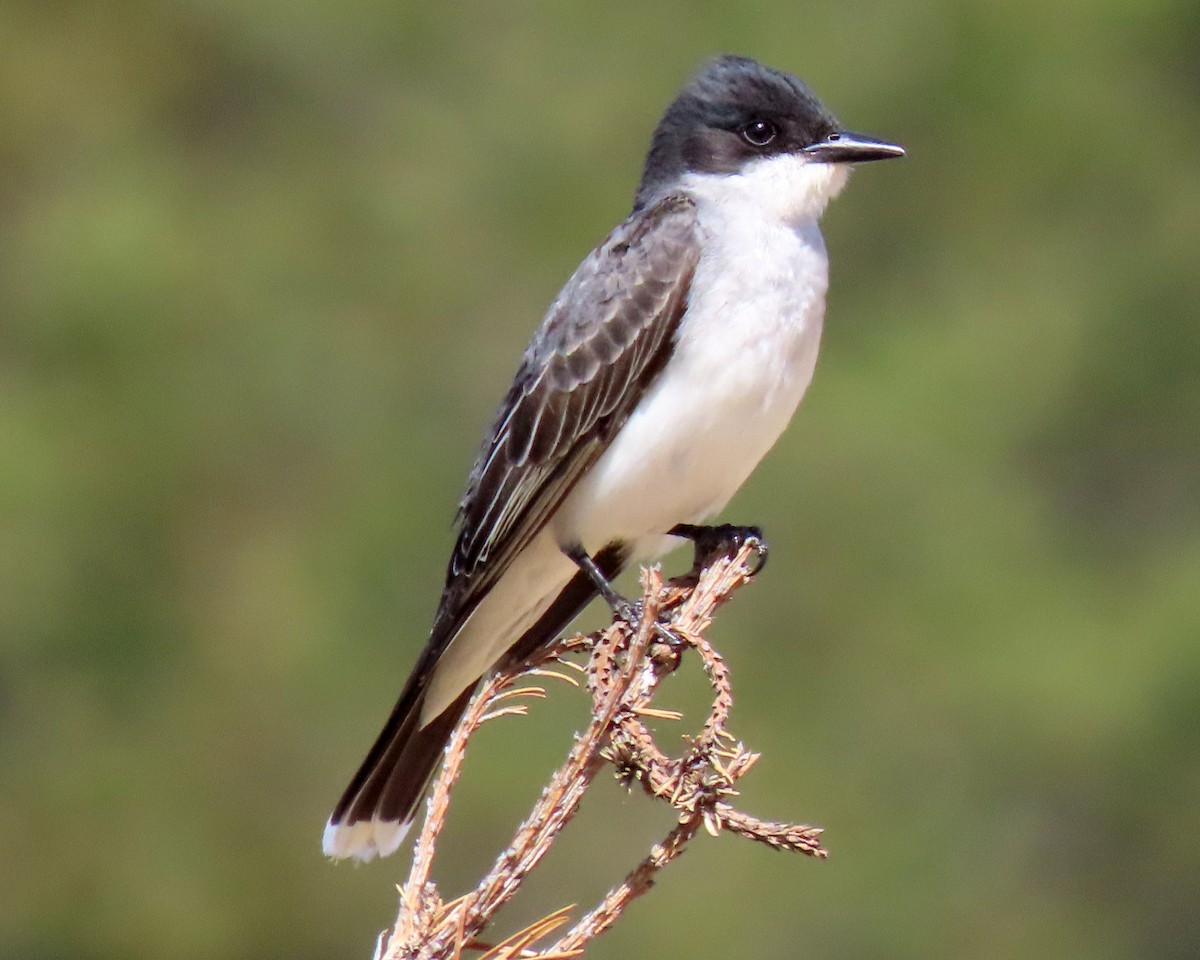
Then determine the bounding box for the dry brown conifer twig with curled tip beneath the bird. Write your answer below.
[376,542,826,960]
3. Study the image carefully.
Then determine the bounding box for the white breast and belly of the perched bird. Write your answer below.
[553,157,828,554]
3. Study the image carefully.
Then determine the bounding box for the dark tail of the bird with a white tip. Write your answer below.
[322,682,474,862]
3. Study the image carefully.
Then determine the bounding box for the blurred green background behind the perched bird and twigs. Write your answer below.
[0,0,1200,960]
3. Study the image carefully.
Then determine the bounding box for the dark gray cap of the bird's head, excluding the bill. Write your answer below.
[635,55,838,209]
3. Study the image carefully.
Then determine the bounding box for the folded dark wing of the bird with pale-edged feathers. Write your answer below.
[438,197,700,635]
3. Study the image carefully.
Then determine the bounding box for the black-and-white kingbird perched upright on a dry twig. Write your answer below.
[323,55,905,860]
